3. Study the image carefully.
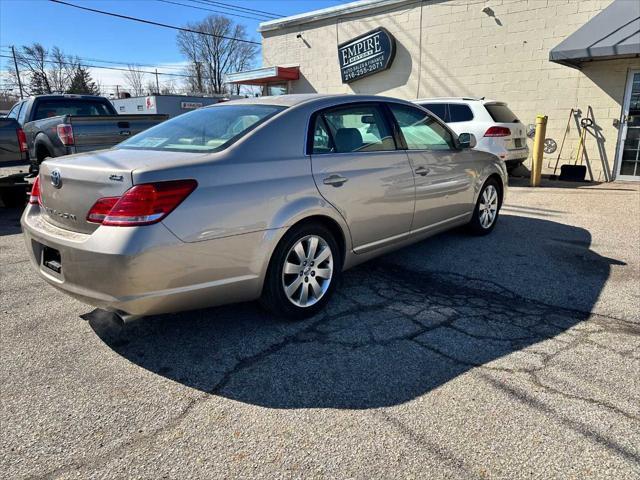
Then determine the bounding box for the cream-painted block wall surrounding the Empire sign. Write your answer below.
[263,0,640,180]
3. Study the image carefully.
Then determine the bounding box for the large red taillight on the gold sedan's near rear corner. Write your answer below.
[87,180,198,227]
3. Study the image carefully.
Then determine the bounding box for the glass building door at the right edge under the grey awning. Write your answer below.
[616,70,640,180]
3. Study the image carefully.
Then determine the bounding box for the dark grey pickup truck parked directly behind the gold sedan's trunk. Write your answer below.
[7,94,168,171]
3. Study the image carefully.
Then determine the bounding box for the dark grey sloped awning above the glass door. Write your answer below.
[549,0,640,68]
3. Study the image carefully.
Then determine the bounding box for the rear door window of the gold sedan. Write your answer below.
[314,105,396,153]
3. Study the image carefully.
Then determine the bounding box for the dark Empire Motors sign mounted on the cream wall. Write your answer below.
[338,27,396,83]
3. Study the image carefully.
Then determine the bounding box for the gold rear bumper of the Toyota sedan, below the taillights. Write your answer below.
[21,205,273,315]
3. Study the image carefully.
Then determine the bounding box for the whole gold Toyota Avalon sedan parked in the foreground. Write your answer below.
[21,95,507,319]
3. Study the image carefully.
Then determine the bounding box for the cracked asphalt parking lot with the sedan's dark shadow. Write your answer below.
[0,178,640,479]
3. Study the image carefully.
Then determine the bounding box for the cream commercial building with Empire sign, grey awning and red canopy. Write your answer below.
[230,0,640,181]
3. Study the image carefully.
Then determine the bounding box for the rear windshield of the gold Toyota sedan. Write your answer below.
[118,104,286,152]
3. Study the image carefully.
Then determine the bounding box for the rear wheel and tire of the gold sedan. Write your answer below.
[260,223,342,320]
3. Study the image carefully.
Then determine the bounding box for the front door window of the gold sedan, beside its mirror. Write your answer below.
[390,104,455,150]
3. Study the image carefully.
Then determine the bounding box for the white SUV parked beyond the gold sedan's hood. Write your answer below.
[413,97,529,171]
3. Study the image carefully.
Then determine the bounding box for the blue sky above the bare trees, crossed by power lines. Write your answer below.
[0,0,347,93]
